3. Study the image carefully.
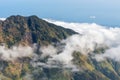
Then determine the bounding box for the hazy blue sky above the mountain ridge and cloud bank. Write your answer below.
[0,0,120,25]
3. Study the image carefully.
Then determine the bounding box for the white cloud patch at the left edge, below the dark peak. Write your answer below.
[0,45,34,61]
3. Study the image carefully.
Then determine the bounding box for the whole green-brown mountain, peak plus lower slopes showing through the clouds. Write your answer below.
[0,15,120,80]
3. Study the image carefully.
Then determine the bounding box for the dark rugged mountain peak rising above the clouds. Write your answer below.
[0,15,76,46]
